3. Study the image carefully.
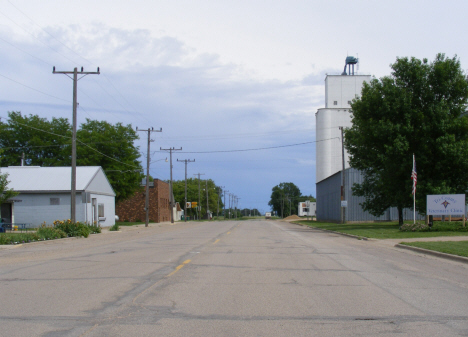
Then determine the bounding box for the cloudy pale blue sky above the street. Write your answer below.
[0,0,468,212]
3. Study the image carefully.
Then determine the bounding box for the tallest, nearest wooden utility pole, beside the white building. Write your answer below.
[52,66,100,223]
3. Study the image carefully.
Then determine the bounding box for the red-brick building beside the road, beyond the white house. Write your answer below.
[115,179,171,222]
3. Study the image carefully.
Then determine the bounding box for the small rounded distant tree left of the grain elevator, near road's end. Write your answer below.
[268,183,301,216]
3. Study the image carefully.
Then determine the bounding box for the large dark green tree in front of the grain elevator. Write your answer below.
[345,54,468,224]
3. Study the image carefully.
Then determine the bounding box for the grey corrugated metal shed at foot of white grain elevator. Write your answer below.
[316,168,424,222]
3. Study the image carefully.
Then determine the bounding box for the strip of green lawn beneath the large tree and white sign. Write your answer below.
[294,220,468,239]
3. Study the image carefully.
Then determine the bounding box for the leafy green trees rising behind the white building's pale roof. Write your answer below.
[0,112,143,200]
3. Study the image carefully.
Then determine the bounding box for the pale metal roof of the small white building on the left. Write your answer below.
[0,166,112,192]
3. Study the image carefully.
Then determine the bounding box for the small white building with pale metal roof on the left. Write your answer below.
[0,166,115,227]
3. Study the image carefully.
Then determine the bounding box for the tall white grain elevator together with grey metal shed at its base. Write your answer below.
[315,56,422,222]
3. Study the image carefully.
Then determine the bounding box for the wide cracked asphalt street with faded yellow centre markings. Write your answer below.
[0,220,468,337]
